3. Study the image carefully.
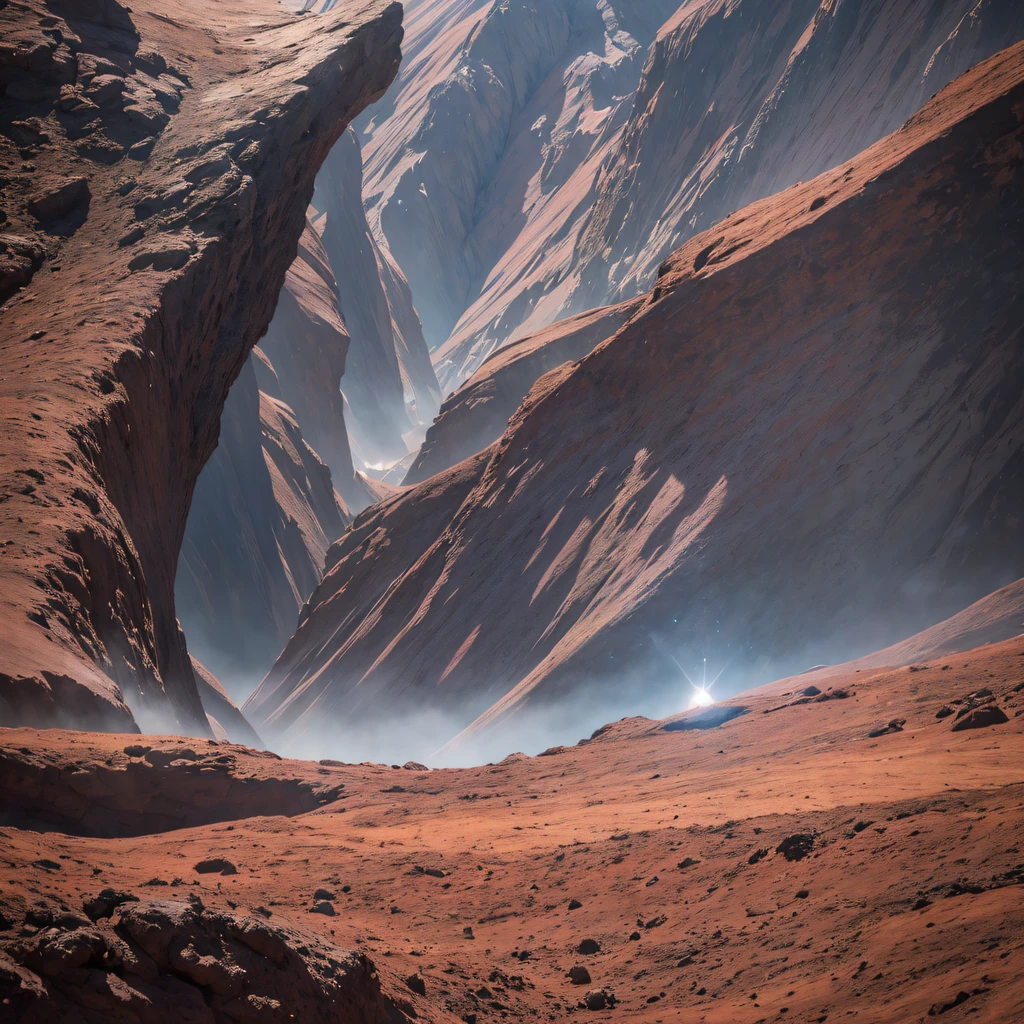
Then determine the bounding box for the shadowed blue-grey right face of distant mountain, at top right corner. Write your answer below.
[570,0,1024,307]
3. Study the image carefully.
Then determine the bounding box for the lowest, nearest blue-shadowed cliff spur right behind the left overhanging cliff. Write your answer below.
[175,352,349,699]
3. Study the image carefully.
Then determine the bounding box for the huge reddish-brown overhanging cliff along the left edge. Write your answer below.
[0,0,401,732]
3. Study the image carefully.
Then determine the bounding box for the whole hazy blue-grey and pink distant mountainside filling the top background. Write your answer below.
[366,0,1024,393]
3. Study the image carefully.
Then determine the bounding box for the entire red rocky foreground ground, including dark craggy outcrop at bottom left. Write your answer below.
[0,637,1024,1024]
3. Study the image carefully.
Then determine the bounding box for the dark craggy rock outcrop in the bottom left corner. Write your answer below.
[0,890,407,1024]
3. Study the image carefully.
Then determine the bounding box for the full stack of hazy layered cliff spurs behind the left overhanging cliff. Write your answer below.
[176,136,439,699]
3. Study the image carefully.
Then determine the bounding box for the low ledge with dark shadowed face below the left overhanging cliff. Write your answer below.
[0,729,344,839]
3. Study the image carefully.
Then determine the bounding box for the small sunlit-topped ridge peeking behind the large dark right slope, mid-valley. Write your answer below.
[402,299,643,484]
